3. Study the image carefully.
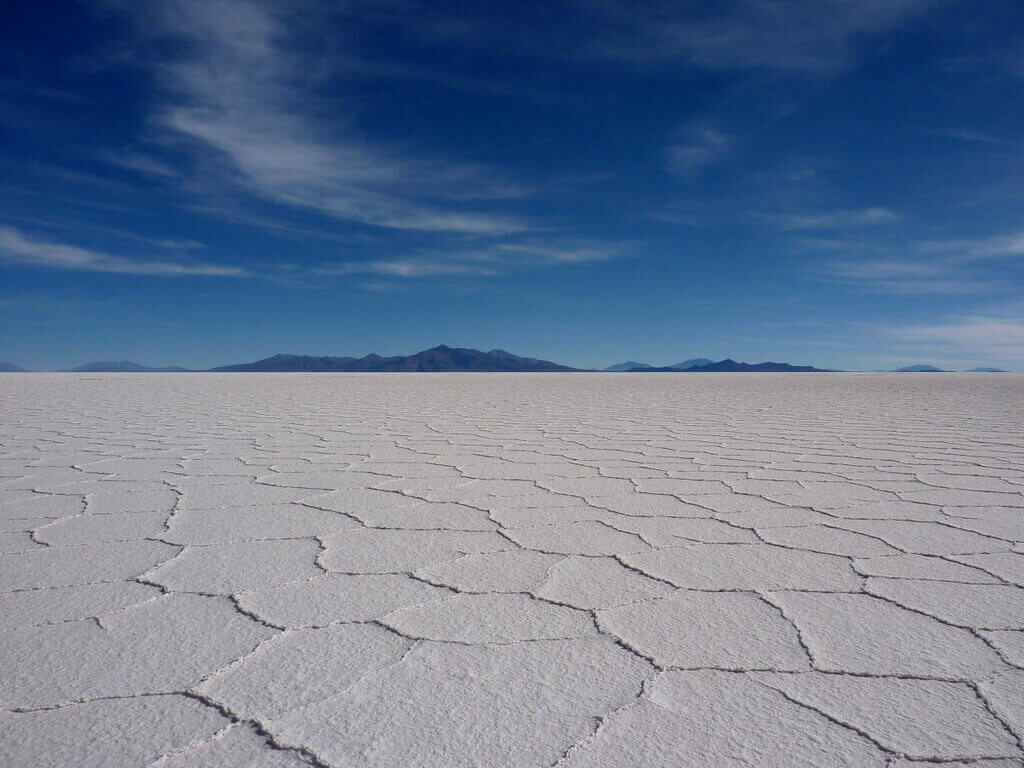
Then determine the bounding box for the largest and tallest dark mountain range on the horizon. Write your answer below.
[212,344,579,373]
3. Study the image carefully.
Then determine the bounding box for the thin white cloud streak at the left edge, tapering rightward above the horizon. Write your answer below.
[0,226,249,278]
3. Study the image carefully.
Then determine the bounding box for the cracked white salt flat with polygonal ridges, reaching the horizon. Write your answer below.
[0,374,1024,768]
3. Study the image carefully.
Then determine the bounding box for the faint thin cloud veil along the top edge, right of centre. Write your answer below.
[385,0,941,76]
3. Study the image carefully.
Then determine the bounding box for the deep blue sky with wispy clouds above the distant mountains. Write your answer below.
[0,0,1024,370]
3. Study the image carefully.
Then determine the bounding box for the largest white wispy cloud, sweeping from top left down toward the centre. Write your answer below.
[112,0,531,236]
